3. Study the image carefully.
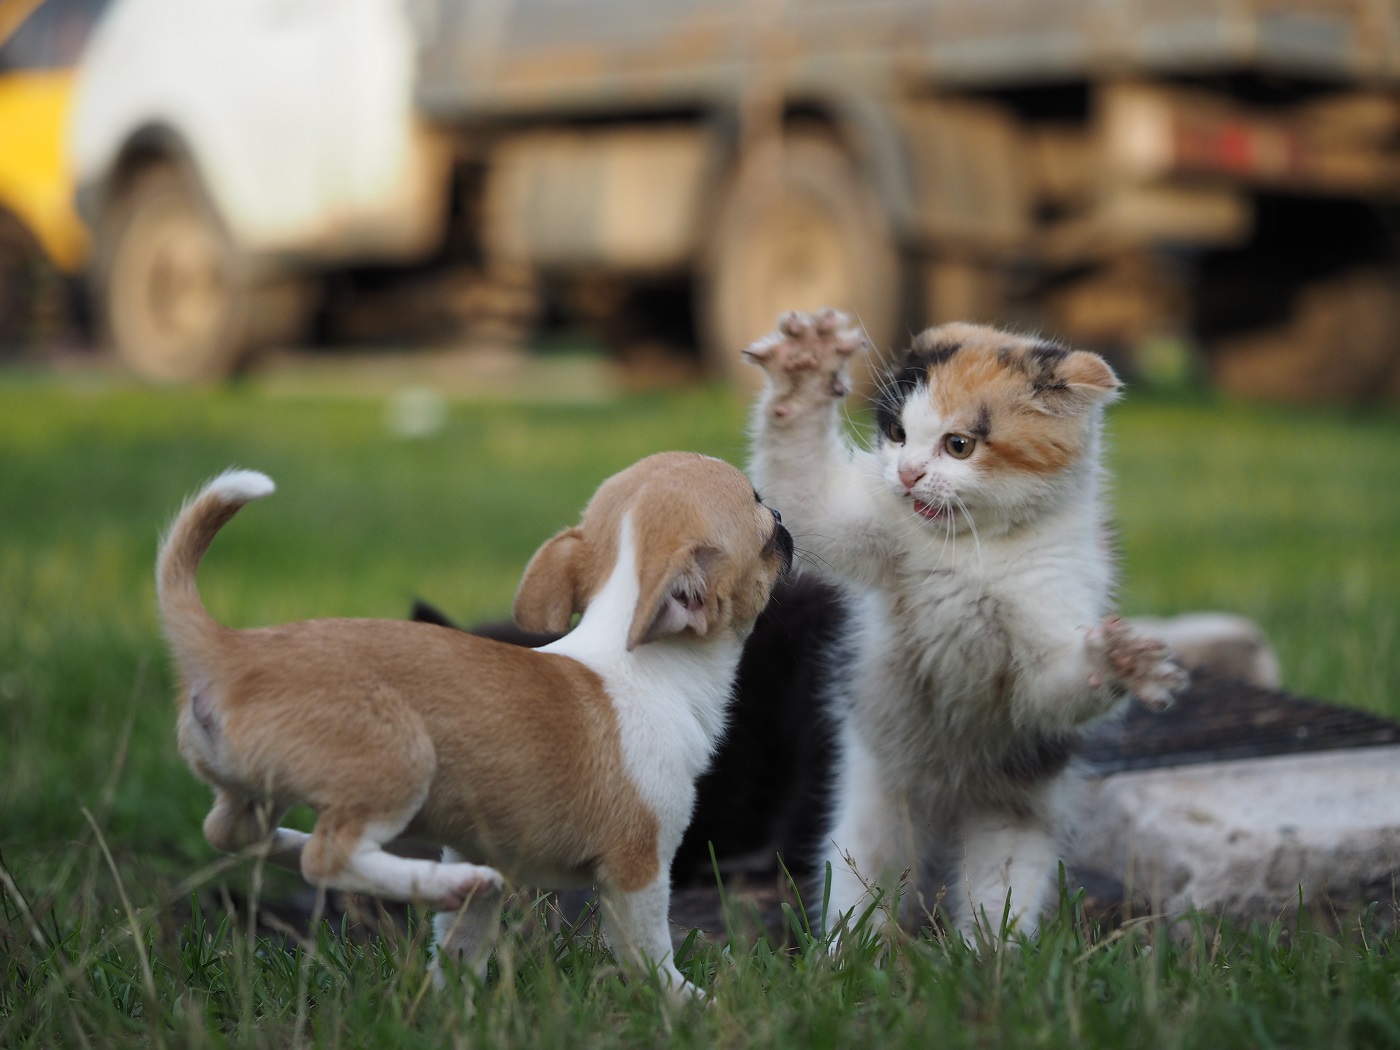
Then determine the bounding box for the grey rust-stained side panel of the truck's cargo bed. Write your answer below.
[419,0,1400,116]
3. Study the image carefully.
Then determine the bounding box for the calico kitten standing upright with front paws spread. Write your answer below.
[745,311,1184,938]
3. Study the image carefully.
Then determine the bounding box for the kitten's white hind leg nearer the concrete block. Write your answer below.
[948,813,1060,945]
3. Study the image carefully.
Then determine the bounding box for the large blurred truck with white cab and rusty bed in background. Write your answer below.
[71,0,1400,399]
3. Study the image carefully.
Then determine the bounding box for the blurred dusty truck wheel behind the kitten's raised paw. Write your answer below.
[697,133,902,389]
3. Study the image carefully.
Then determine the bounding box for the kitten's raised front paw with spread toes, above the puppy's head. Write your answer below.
[743,309,867,417]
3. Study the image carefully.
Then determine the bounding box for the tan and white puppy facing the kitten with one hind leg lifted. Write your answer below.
[155,452,792,994]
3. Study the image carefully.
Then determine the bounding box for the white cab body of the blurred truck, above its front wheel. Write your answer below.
[70,0,447,260]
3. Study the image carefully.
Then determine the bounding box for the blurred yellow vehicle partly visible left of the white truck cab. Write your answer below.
[0,0,106,351]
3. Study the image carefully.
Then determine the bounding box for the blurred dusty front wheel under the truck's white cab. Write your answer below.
[98,167,267,384]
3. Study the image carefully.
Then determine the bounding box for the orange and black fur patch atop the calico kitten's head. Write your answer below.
[876,323,1120,475]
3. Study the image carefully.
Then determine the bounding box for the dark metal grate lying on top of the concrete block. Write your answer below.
[1081,678,1400,773]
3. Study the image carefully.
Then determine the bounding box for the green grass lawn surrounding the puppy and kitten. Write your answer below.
[0,377,1400,1050]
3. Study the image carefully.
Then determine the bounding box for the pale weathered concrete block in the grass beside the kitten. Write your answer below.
[1068,746,1400,918]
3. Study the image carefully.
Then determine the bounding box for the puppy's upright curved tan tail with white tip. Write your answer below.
[155,470,274,671]
